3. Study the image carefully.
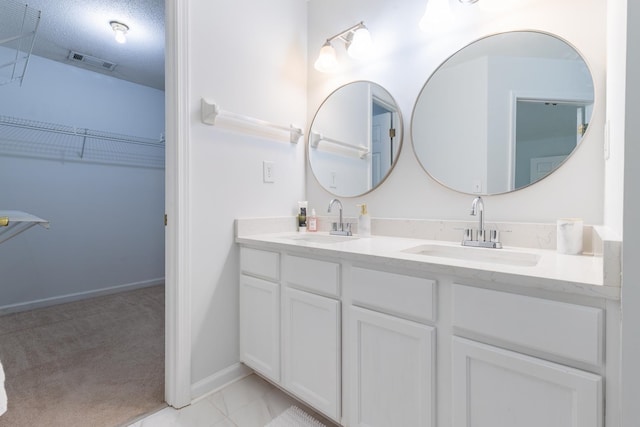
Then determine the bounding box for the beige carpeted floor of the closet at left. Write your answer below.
[0,286,165,427]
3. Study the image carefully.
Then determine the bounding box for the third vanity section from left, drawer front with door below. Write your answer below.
[347,267,435,427]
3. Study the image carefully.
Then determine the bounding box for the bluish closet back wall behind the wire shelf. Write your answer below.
[0,57,164,309]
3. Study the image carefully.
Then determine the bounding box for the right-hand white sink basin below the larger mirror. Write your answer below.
[402,244,540,267]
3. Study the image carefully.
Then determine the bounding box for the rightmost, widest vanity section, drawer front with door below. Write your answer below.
[452,285,604,427]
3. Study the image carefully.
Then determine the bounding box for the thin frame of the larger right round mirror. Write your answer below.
[409,30,598,196]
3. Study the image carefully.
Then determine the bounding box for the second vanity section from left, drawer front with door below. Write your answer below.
[282,255,342,420]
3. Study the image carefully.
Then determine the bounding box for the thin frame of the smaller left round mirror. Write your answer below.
[305,80,405,198]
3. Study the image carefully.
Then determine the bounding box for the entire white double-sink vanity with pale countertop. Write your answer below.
[236,220,620,427]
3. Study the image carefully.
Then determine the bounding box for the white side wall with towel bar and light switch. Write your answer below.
[185,0,307,394]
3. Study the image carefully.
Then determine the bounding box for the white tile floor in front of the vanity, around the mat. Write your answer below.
[129,374,336,427]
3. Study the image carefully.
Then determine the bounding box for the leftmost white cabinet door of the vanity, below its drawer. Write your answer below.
[240,274,280,382]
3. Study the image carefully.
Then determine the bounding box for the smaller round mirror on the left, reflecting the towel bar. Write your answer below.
[308,81,402,197]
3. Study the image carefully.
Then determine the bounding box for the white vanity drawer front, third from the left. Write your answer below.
[351,267,436,322]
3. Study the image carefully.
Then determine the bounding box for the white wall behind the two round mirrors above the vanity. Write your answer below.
[307,0,606,224]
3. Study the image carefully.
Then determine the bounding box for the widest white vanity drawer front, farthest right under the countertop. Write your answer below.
[453,285,604,366]
